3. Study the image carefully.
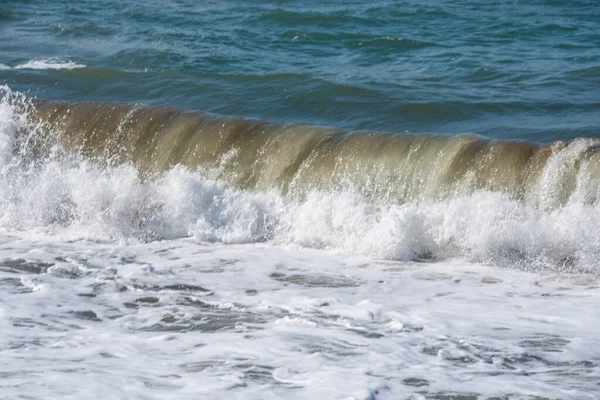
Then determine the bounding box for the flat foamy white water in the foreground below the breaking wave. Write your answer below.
[0,239,600,400]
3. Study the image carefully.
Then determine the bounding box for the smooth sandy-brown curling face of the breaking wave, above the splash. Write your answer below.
[31,95,600,210]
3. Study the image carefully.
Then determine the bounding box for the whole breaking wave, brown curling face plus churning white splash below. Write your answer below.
[0,87,600,272]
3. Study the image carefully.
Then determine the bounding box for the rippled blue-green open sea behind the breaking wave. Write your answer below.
[0,0,600,142]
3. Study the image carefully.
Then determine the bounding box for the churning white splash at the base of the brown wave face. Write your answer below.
[0,88,600,273]
